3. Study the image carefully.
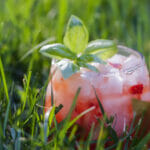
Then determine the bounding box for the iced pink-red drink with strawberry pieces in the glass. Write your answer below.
[45,46,150,136]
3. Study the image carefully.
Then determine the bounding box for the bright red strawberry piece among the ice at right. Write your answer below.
[130,84,143,94]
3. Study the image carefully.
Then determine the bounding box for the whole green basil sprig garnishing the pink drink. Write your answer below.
[40,16,117,79]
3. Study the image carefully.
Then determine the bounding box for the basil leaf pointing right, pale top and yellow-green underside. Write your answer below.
[85,39,118,60]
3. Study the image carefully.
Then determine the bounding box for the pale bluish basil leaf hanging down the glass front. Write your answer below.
[57,60,80,79]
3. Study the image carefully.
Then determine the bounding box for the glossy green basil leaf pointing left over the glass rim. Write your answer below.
[40,43,76,60]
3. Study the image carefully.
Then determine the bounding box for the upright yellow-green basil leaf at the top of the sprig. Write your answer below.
[64,16,89,54]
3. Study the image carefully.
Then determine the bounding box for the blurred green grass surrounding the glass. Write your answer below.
[0,0,150,150]
